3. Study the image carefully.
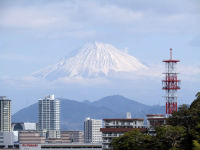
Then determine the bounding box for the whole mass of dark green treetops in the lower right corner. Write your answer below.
[111,92,200,150]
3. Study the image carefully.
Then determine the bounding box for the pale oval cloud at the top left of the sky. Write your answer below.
[1,8,66,29]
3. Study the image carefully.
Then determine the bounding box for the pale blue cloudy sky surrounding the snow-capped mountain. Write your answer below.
[0,0,200,112]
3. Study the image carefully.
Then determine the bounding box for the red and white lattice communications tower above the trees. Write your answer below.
[162,48,181,116]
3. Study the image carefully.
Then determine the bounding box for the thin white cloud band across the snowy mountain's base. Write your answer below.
[0,64,200,89]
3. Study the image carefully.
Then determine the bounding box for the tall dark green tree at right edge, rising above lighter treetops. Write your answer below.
[167,92,200,150]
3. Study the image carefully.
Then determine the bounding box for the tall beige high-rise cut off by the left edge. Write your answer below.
[0,96,11,132]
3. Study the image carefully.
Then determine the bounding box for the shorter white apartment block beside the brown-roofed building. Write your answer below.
[84,118,102,143]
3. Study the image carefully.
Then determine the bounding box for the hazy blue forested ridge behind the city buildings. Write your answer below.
[12,95,165,130]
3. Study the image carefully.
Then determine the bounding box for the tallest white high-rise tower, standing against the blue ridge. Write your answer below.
[38,95,60,138]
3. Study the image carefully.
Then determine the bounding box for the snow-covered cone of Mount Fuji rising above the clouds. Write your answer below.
[32,42,147,81]
